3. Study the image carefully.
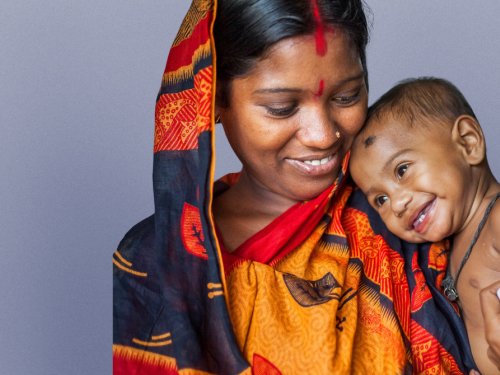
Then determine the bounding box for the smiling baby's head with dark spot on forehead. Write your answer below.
[350,77,489,242]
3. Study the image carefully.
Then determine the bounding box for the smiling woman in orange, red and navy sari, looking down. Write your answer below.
[113,0,475,374]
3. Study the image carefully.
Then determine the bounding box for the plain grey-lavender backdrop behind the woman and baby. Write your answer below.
[0,0,500,375]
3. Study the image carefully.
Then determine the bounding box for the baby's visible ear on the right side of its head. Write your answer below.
[451,115,486,165]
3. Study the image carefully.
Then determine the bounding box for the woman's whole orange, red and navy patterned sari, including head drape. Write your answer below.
[113,0,475,375]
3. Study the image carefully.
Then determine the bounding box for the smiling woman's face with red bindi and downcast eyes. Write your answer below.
[216,31,368,201]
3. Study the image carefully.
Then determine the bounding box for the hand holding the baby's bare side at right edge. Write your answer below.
[480,281,500,371]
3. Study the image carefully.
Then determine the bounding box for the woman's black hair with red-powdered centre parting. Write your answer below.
[213,0,368,107]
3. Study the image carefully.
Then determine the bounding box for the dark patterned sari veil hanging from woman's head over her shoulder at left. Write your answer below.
[113,0,248,374]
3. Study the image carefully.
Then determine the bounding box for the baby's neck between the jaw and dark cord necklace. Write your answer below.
[455,166,500,239]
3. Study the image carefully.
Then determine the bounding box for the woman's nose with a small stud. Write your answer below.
[298,111,338,150]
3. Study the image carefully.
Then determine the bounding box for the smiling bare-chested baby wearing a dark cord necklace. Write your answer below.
[350,78,500,375]
